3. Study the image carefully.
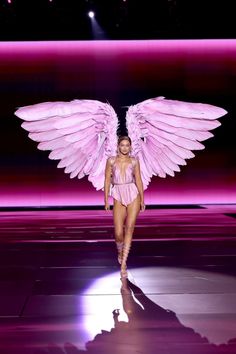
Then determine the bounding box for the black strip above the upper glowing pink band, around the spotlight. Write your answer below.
[0,0,236,41]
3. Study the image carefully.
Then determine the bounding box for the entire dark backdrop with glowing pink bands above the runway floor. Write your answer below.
[0,0,236,207]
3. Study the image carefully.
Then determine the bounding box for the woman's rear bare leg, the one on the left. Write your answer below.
[113,199,126,264]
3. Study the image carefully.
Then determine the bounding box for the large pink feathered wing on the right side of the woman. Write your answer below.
[126,97,227,189]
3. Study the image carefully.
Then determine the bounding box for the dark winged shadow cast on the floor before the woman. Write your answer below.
[34,279,236,354]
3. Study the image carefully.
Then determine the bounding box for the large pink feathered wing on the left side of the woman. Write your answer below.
[15,100,118,190]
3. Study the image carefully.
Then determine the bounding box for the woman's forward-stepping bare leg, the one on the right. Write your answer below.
[121,195,140,275]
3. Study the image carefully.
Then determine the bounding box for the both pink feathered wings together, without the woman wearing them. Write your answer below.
[15,97,227,190]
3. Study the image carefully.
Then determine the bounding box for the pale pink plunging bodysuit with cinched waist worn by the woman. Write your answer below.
[111,157,139,206]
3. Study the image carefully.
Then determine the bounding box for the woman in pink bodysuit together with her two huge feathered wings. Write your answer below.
[15,96,227,277]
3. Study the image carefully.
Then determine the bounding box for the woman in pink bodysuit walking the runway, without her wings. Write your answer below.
[104,136,145,278]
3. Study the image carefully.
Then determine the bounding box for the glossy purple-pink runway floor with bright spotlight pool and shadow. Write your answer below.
[0,205,236,354]
